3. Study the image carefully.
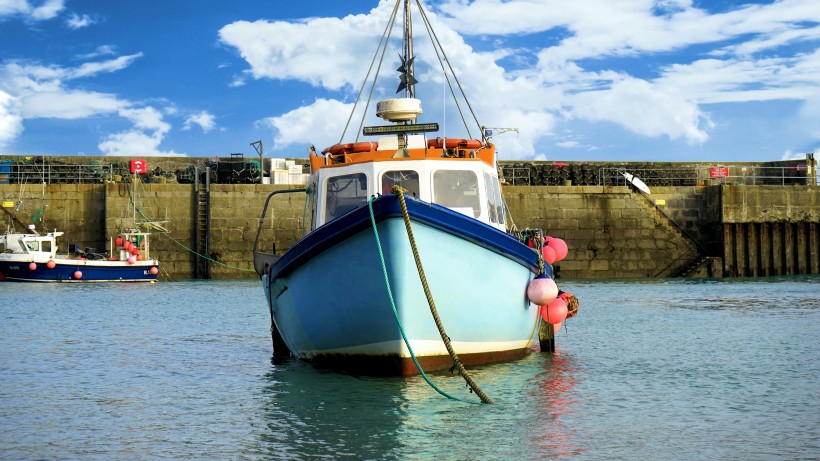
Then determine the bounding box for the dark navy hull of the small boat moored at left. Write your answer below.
[0,255,159,283]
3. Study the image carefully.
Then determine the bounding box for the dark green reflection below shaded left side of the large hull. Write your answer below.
[255,360,406,459]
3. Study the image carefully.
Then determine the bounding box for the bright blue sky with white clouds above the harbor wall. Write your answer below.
[0,0,820,162]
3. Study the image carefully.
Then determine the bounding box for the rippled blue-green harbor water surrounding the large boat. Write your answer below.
[0,277,820,460]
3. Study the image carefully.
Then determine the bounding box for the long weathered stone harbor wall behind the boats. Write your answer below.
[0,183,820,279]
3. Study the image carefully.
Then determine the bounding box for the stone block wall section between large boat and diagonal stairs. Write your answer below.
[502,186,700,279]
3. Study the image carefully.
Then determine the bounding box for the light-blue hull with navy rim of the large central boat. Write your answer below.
[263,196,539,375]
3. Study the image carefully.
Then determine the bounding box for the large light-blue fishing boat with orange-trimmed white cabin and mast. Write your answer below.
[254,0,572,375]
